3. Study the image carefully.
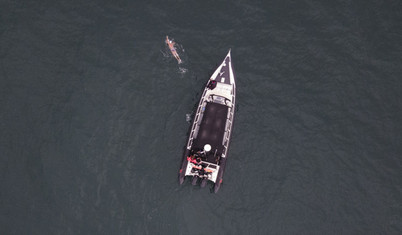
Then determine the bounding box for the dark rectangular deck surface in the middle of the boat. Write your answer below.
[194,103,228,153]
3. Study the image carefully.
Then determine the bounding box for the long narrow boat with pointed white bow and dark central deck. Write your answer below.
[179,50,236,193]
